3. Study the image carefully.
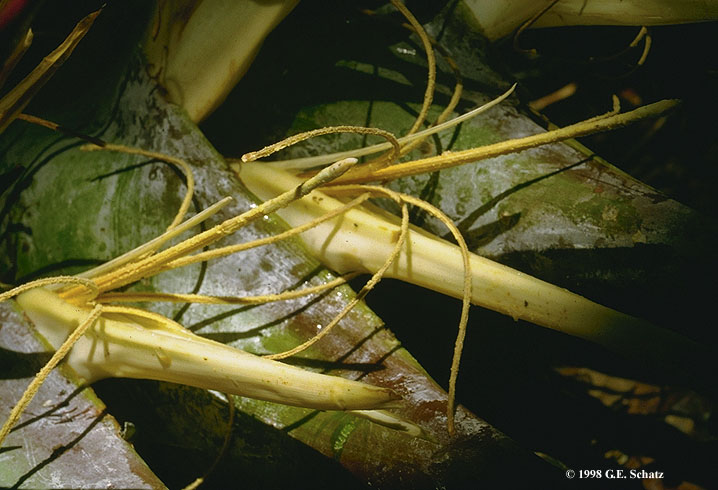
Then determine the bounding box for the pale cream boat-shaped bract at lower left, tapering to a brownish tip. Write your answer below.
[16,288,397,410]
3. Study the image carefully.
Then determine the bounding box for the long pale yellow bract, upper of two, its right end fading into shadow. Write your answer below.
[239,163,697,376]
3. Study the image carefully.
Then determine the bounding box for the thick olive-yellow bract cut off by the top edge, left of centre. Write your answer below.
[145,0,298,121]
